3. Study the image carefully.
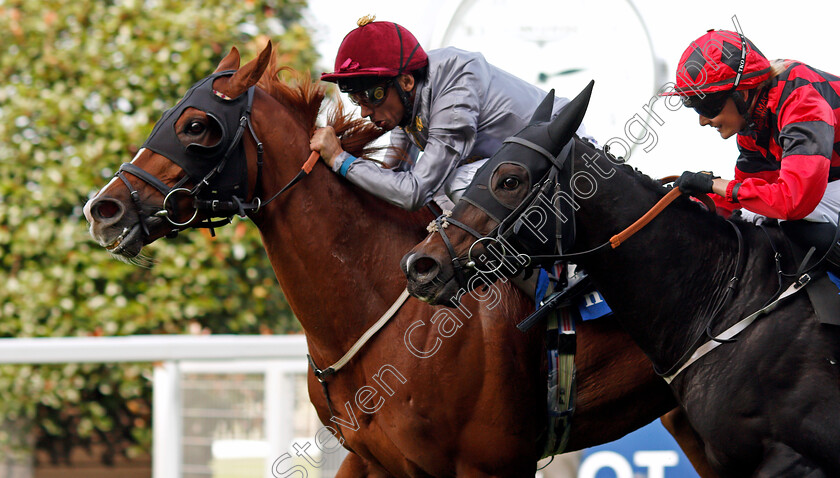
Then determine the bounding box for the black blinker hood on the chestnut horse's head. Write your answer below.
[142,70,253,198]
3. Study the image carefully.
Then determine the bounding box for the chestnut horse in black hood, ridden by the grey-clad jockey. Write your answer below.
[85,43,704,477]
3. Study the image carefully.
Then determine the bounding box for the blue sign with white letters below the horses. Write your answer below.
[578,420,699,478]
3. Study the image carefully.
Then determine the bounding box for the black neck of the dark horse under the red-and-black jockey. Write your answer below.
[577,159,737,367]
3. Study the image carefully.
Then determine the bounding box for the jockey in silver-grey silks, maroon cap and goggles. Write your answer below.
[310,17,585,210]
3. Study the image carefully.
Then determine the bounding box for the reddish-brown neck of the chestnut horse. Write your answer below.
[255,106,425,359]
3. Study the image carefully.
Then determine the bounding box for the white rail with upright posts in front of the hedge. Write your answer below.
[0,335,307,478]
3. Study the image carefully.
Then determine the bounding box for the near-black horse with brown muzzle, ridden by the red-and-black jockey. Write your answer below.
[403,80,840,477]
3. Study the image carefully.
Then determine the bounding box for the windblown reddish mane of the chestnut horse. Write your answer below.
[257,56,385,158]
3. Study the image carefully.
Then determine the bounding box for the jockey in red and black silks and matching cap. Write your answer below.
[661,30,840,268]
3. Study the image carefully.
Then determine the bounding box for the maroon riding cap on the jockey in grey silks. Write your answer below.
[321,17,429,82]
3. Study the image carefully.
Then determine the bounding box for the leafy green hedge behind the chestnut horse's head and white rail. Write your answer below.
[0,0,316,461]
